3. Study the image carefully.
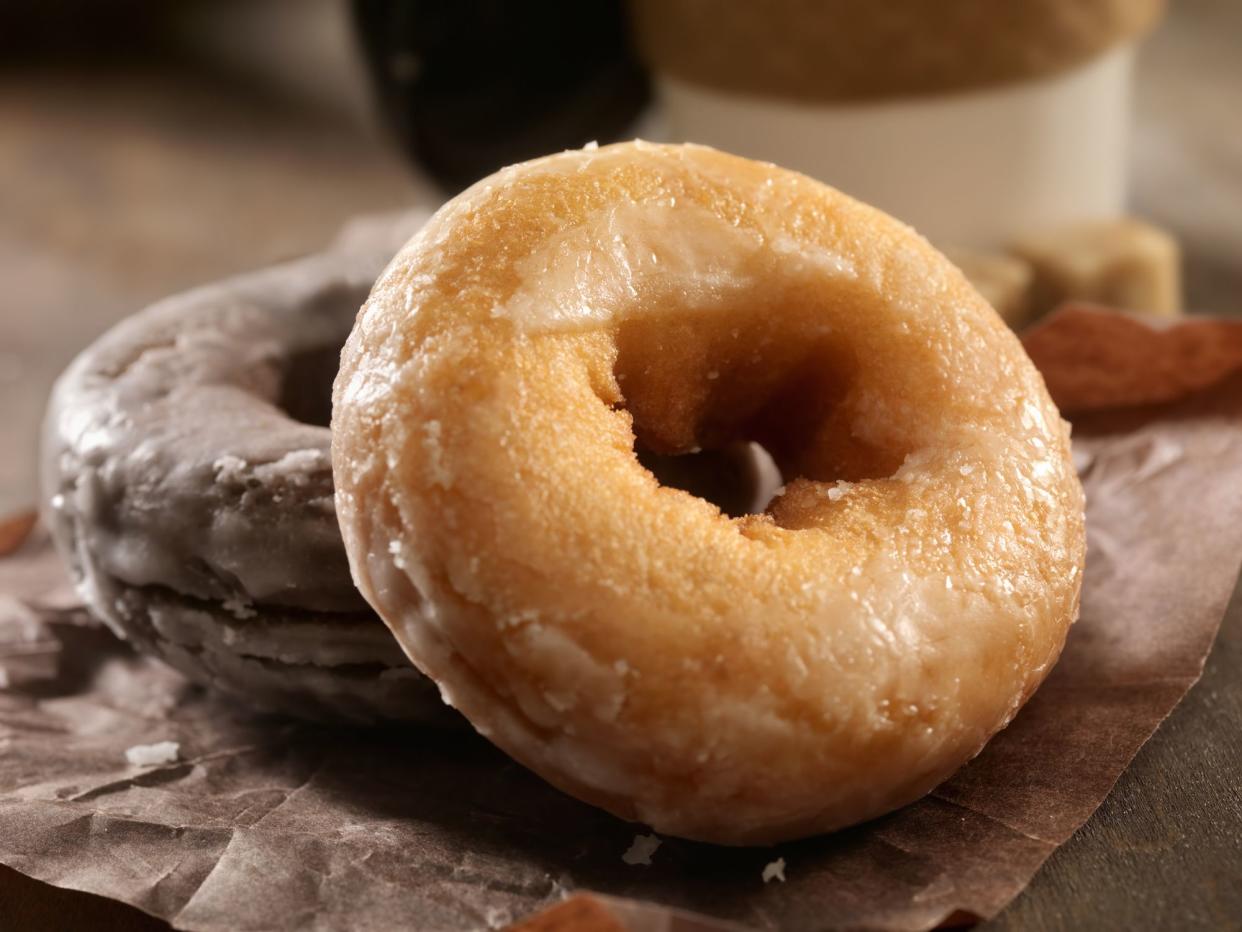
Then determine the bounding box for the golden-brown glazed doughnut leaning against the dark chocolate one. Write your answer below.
[332,143,1084,844]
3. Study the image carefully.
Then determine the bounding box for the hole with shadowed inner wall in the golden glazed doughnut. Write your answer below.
[614,306,914,523]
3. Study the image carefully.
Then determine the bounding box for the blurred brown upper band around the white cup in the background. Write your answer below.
[631,0,1164,101]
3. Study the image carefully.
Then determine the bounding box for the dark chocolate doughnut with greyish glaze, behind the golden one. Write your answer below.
[43,216,442,718]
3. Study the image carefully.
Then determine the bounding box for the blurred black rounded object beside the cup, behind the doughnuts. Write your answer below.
[354,0,647,190]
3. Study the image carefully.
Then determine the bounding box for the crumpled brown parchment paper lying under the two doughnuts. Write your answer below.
[0,308,1242,932]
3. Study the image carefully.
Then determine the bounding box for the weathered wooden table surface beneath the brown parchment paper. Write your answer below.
[0,0,1242,930]
